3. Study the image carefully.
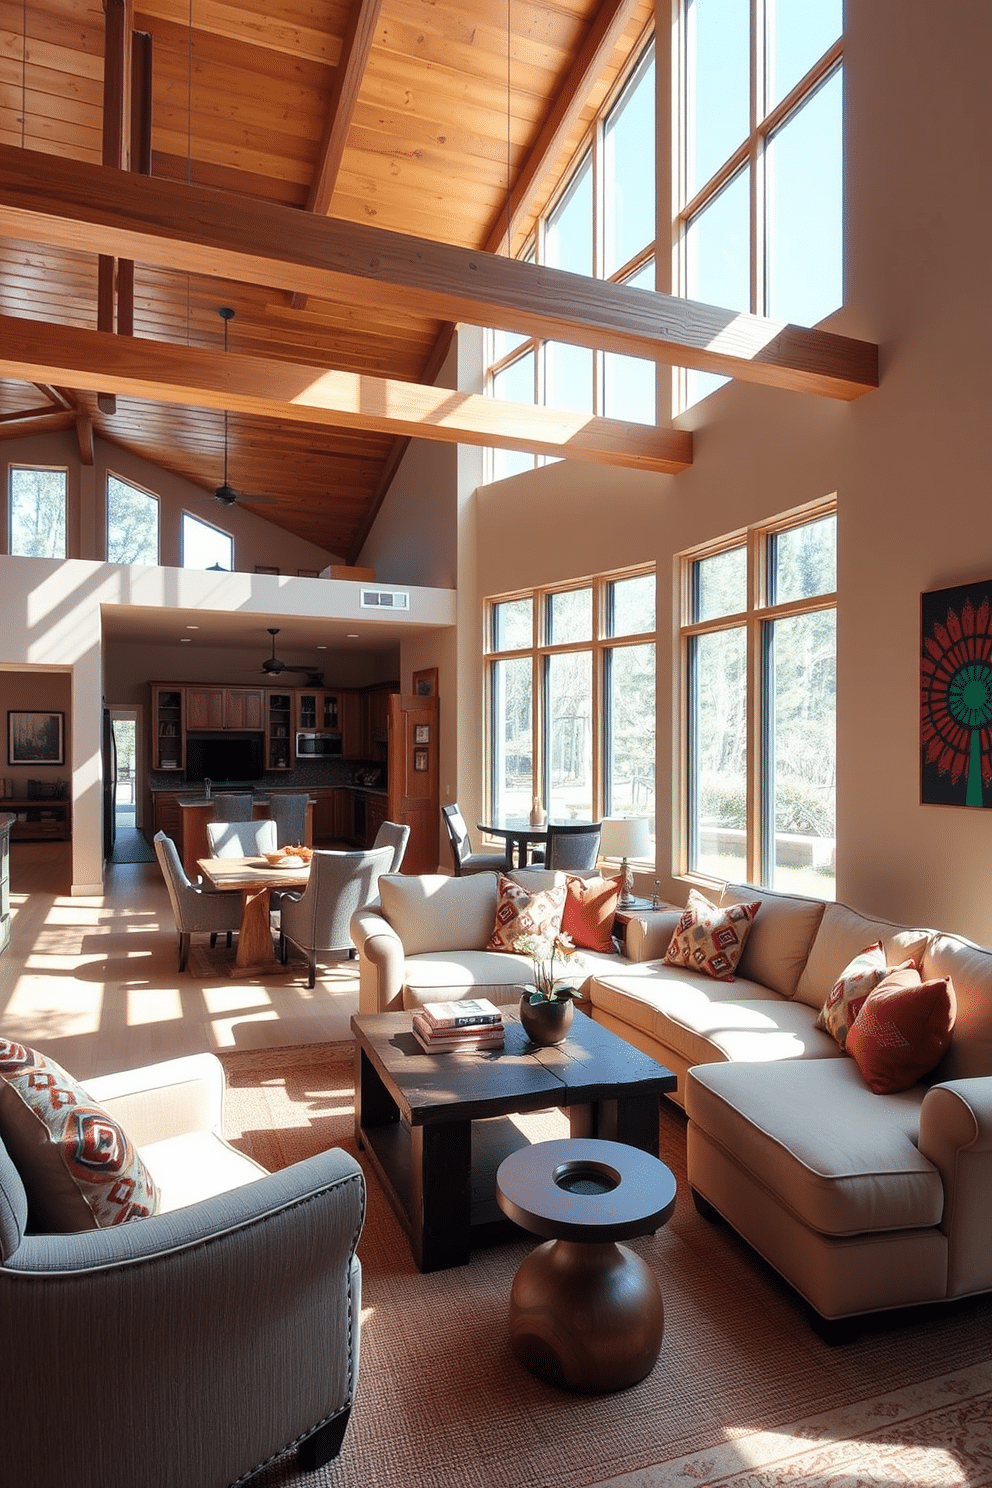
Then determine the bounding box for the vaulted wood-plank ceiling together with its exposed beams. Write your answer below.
[0,0,876,559]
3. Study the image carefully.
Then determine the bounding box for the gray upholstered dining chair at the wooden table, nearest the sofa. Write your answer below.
[280,847,394,987]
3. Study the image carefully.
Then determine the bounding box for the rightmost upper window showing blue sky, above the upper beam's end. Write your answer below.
[677,0,843,405]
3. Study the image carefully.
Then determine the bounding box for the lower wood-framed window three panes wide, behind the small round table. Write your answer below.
[488,570,656,838]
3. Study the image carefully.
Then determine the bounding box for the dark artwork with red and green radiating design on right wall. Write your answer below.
[919,579,992,806]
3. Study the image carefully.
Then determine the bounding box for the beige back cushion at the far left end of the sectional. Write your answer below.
[379,873,497,955]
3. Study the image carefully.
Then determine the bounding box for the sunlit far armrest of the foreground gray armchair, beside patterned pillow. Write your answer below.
[80,1054,225,1147]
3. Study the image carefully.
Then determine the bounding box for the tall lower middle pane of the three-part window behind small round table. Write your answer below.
[544,652,593,821]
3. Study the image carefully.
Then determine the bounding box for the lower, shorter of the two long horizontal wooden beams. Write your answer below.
[0,315,692,475]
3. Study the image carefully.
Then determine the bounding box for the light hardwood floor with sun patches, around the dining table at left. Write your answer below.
[0,842,358,1079]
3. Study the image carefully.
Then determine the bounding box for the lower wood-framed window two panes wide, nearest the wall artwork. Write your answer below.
[681,507,837,899]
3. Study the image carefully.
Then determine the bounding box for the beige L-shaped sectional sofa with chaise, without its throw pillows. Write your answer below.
[352,872,992,1320]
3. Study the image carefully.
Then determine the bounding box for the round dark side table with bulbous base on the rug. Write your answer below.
[497,1137,675,1393]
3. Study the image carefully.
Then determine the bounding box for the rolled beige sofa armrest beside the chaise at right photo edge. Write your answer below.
[919,1076,992,1296]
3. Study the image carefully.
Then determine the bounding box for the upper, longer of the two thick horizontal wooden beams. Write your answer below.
[0,144,877,399]
